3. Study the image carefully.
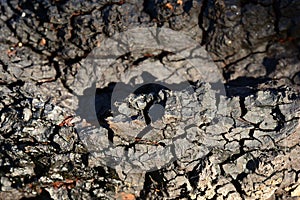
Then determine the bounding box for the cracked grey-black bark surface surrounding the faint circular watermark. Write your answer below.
[0,0,300,199]
